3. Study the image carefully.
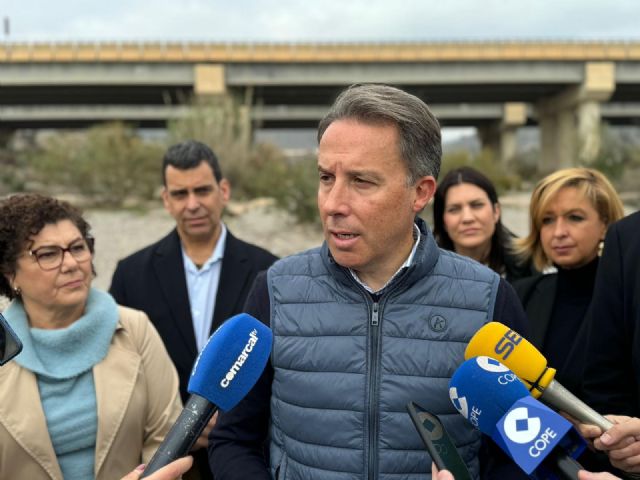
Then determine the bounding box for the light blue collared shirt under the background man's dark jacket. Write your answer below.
[182,223,227,352]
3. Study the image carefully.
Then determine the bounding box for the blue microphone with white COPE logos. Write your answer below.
[449,356,585,480]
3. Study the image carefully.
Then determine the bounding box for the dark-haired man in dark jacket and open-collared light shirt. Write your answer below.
[110,141,276,478]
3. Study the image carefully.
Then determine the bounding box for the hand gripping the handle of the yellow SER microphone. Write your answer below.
[593,415,640,473]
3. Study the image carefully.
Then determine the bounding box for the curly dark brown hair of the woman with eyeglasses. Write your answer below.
[0,193,95,299]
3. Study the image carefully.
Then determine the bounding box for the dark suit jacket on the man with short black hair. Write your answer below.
[109,230,277,401]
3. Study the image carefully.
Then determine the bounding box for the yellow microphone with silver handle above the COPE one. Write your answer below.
[464,322,613,432]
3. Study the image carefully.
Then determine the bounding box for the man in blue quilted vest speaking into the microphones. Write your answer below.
[209,85,526,480]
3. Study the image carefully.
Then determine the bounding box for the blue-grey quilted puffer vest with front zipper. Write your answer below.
[268,221,499,480]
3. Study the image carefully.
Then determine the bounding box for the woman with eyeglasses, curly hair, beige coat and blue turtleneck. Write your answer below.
[0,194,181,480]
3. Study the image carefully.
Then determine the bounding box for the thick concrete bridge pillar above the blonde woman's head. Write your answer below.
[537,62,615,173]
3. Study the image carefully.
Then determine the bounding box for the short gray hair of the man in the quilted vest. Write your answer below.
[318,84,442,181]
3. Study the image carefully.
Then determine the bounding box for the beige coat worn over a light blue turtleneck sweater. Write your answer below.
[0,307,182,480]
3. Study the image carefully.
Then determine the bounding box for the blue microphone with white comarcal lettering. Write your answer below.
[141,313,273,478]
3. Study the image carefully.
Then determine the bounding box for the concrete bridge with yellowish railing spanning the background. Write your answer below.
[0,42,640,170]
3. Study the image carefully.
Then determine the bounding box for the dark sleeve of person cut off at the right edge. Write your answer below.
[583,212,640,417]
